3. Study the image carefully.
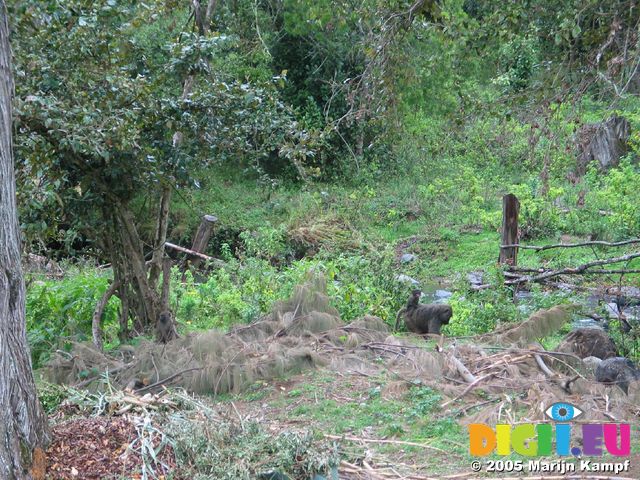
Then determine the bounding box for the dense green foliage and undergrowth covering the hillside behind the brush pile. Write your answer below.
[10,0,640,358]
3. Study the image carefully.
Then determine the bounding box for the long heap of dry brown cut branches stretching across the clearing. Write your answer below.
[48,276,640,424]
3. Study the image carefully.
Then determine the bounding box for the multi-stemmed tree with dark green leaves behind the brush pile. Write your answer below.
[11,0,296,339]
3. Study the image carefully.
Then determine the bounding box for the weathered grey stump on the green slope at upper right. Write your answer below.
[576,115,630,172]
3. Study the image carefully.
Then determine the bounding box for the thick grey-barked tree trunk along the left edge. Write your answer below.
[0,0,48,480]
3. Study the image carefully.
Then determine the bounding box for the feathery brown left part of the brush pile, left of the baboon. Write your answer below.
[45,276,389,394]
